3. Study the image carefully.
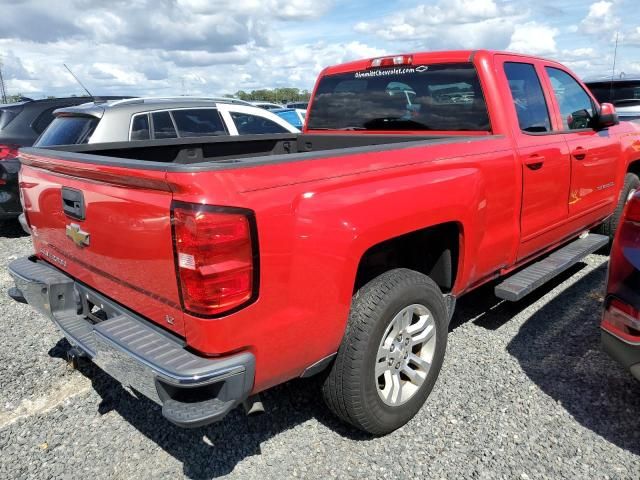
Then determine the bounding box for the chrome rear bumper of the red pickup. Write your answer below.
[9,257,255,427]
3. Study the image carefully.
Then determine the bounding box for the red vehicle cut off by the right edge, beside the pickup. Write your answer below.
[602,188,640,380]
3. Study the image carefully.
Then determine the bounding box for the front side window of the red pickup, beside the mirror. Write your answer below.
[545,67,594,130]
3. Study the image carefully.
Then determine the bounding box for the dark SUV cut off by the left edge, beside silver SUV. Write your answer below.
[0,97,130,227]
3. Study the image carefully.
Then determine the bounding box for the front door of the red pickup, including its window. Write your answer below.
[545,66,621,224]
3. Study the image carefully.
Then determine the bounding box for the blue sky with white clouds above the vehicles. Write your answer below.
[0,0,640,98]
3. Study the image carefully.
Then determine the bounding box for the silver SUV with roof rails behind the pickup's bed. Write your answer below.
[35,97,299,147]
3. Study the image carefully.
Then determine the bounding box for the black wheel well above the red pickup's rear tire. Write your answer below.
[354,222,460,292]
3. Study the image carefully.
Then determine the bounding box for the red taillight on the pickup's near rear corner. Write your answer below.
[172,202,258,317]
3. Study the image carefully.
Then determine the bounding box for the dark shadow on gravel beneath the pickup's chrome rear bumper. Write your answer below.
[49,339,372,480]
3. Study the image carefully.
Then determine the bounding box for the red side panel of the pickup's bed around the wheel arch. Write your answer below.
[167,137,521,391]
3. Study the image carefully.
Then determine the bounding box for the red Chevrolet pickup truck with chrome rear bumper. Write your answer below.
[9,51,640,434]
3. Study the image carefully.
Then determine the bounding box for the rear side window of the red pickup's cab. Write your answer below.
[504,62,551,133]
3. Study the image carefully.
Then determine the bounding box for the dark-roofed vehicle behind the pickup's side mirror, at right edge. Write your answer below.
[585,77,640,121]
